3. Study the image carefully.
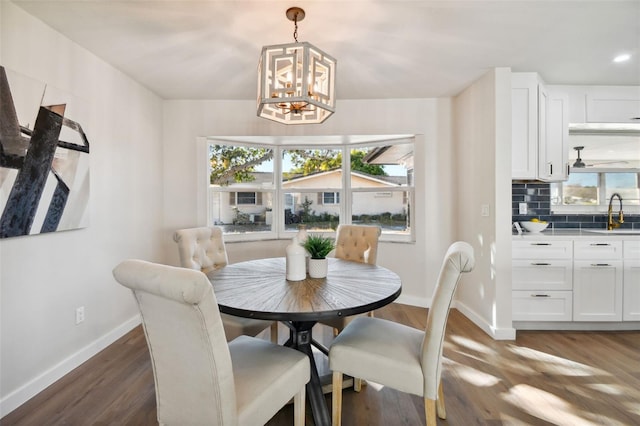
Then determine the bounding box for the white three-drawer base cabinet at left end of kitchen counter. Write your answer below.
[511,240,573,321]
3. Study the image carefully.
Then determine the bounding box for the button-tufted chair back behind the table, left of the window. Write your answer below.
[173,226,229,273]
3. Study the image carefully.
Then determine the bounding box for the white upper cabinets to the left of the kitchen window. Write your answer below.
[511,73,569,182]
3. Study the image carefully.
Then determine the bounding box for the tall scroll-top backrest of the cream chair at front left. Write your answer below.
[113,260,237,425]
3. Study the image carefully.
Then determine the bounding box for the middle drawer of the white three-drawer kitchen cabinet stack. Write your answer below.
[511,259,573,290]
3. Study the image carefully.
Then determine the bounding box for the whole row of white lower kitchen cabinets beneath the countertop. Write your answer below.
[511,238,640,327]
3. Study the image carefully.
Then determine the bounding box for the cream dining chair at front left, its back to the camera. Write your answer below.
[113,260,310,426]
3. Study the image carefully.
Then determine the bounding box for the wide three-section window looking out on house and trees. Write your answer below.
[207,137,414,241]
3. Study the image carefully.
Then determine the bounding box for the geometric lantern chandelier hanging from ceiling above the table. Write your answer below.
[257,7,336,124]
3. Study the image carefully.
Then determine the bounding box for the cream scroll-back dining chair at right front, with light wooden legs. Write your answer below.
[329,241,475,426]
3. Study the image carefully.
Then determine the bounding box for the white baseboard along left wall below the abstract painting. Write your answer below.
[0,314,140,419]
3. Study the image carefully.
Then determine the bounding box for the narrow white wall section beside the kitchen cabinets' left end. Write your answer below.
[454,68,515,339]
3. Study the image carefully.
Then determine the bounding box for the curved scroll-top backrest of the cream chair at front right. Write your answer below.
[421,241,475,400]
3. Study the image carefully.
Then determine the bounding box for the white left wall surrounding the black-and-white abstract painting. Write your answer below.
[0,1,163,417]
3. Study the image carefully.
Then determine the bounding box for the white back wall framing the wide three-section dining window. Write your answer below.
[163,99,457,306]
